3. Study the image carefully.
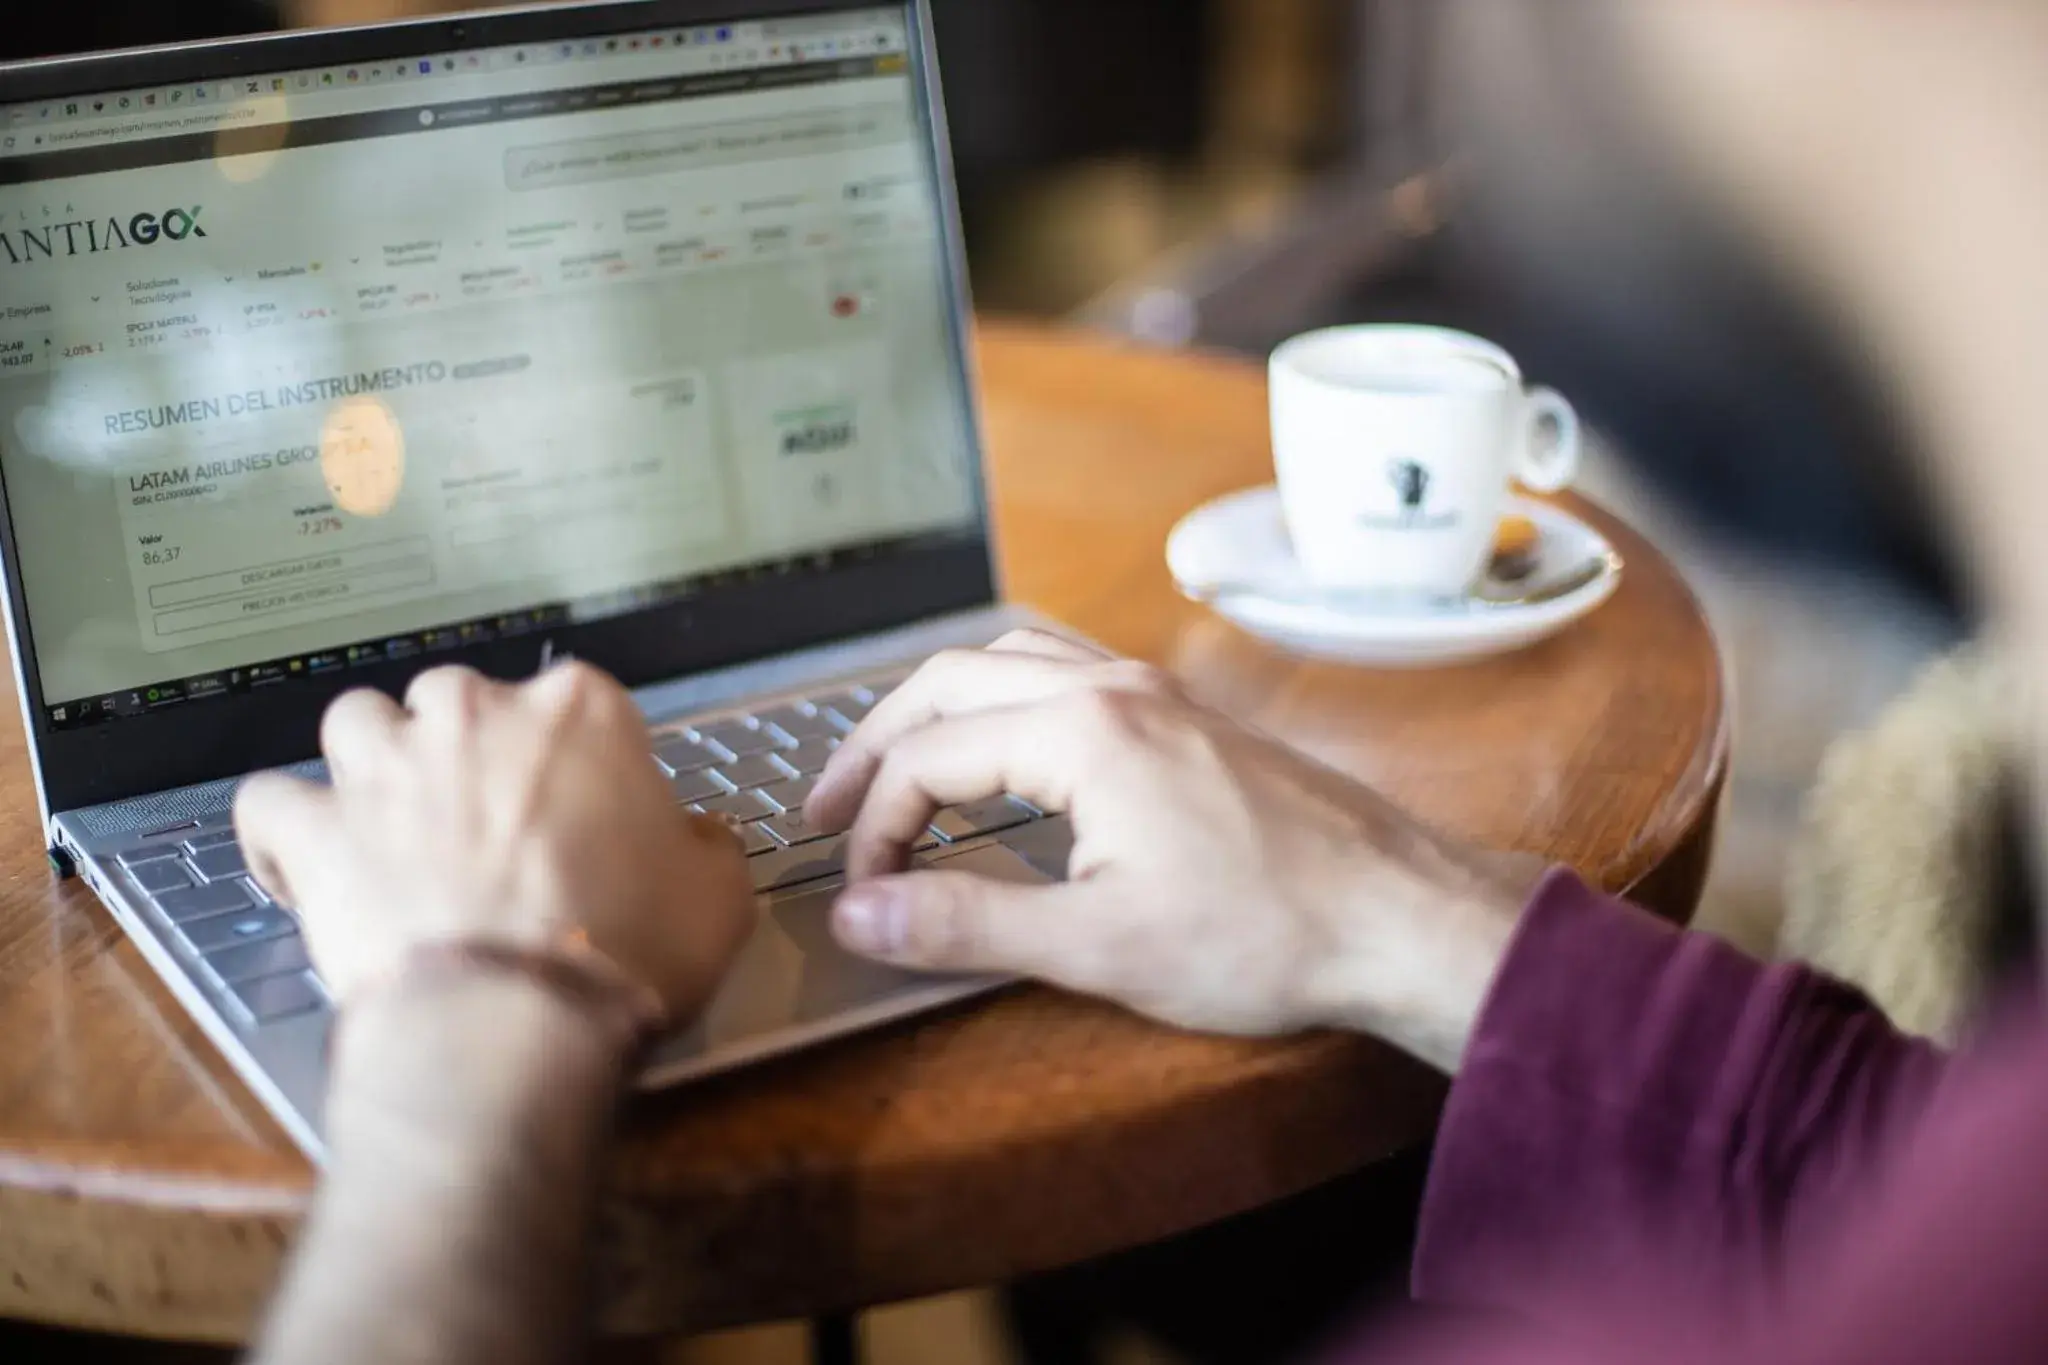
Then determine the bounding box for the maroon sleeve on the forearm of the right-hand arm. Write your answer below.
[1415,872,1946,1326]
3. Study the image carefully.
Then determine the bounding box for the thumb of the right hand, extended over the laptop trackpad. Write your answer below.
[831,872,1108,990]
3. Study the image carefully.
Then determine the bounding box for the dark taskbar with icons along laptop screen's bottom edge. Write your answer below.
[43,536,944,731]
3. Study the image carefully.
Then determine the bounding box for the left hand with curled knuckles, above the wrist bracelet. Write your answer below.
[236,663,754,1035]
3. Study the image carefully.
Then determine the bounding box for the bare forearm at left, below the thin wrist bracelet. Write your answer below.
[256,974,623,1365]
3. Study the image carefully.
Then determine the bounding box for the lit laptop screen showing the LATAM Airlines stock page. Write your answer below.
[0,6,981,731]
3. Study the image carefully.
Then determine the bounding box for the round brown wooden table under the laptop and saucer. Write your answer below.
[0,325,1729,1340]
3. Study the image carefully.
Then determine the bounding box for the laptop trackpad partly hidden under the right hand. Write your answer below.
[692,845,1049,1054]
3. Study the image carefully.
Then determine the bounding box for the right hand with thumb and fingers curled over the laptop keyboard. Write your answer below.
[807,632,1542,1070]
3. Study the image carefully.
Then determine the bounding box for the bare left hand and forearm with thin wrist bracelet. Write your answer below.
[236,665,754,1365]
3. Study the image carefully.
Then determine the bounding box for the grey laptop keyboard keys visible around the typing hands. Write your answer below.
[101,684,1042,1025]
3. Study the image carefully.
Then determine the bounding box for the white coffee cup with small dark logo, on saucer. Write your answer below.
[1272,325,1579,598]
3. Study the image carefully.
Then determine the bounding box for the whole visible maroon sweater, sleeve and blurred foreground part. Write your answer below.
[1350,874,2048,1365]
